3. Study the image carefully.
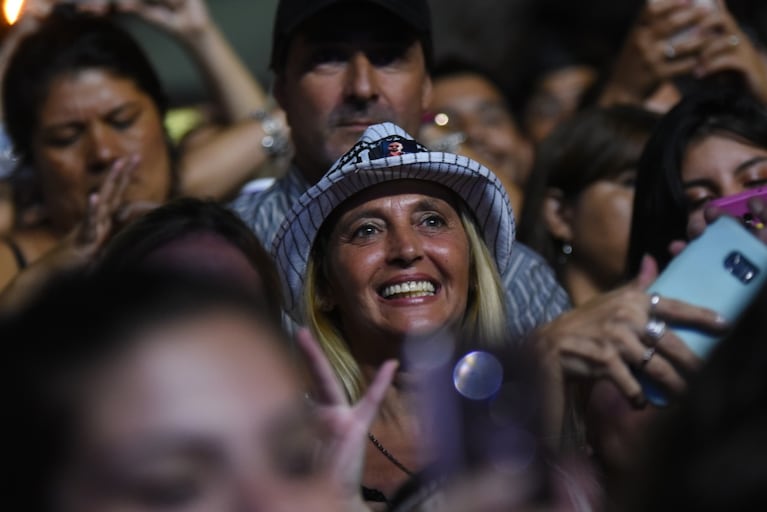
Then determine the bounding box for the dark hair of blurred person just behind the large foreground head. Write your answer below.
[98,197,282,320]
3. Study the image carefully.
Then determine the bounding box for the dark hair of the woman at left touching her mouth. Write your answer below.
[2,6,167,163]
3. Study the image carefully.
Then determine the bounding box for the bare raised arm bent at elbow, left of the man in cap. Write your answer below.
[117,0,286,199]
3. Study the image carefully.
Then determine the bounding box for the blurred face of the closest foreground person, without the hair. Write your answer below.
[57,309,344,512]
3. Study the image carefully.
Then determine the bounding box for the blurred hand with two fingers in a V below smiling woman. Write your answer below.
[296,329,398,507]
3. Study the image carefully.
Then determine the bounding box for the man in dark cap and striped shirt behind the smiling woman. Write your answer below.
[233,0,568,338]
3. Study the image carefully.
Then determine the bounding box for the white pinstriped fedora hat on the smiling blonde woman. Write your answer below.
[272,123,514,321]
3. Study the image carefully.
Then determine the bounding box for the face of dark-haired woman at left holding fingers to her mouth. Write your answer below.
[32,69,171,230]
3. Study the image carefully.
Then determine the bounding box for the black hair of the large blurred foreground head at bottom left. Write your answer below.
[0,270,283,512]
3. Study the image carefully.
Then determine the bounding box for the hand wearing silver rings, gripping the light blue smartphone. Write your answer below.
[534,256,726,405]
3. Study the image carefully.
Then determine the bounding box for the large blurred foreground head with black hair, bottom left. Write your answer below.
[0,271,342,512]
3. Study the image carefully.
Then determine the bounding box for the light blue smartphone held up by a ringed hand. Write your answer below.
[639,217,767,406]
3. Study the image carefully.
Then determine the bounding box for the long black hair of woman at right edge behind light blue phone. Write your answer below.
[627,88,767,275]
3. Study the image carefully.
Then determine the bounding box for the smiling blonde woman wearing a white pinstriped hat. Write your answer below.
[274,123,514,506]
